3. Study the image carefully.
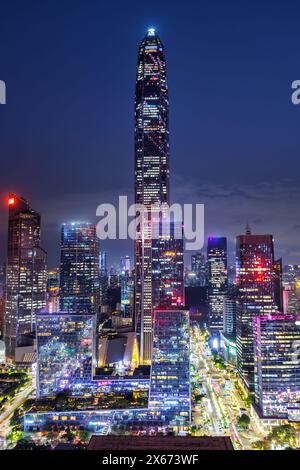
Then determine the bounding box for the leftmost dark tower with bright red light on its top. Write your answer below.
[4,194,47,358]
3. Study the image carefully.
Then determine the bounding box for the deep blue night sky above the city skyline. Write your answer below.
[0,0,300,267]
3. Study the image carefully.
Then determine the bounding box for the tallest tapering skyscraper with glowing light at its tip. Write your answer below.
[135,28,169,364]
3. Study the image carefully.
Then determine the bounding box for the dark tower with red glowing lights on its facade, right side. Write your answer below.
[236,229,277,390]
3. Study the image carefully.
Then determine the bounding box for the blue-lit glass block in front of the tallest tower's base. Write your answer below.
[149,308,191,426]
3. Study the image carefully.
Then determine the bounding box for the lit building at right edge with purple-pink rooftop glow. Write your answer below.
[253,314,300,418]
